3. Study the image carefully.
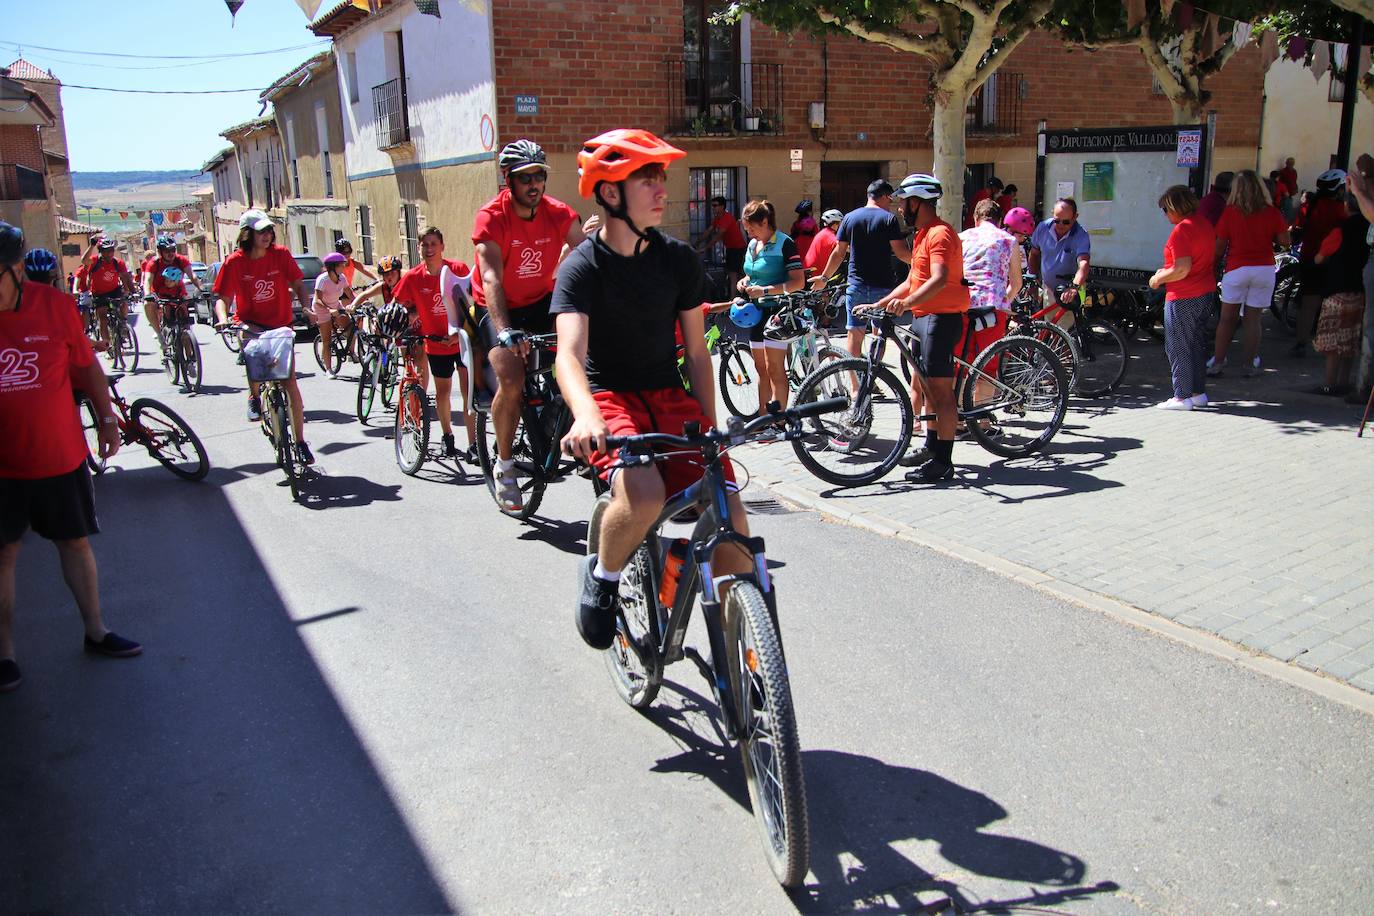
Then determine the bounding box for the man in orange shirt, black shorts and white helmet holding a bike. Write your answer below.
[878,173,969,482]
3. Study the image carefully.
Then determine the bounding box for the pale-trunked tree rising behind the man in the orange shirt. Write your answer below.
[730,0,1054,224]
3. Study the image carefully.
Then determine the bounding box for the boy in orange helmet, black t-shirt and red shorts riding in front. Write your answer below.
[550,129,747,650]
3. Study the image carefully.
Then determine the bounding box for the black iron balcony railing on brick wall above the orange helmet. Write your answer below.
[664,58,783,137]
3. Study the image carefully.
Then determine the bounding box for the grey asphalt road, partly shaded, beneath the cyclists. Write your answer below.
[0,328,1374,913]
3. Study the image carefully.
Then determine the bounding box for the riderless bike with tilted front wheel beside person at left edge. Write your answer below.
[77,372,210,481]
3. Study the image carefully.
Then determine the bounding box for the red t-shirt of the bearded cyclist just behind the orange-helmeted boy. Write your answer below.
[473,191,577,309]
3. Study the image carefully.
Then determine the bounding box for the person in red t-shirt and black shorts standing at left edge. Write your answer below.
[0,222,143,694]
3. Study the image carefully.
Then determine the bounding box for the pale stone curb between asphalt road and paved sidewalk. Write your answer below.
[754,477,1374,715]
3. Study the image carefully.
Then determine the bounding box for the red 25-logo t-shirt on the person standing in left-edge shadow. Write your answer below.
[0,282,95,481]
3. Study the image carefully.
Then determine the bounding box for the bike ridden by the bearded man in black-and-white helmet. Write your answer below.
[463,332,578,520]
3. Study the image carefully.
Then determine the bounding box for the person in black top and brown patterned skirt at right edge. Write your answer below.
[1312,201,1370,396]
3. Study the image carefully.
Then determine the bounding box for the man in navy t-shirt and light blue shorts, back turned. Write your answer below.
[812,179,911,356]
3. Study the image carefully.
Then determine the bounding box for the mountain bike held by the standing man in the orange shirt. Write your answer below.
[791,306,1069,486]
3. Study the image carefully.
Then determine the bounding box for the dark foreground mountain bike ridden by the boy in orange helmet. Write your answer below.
[587,398,848,887]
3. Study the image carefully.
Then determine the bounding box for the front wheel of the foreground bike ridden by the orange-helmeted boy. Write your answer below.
[723,582,811,887]
